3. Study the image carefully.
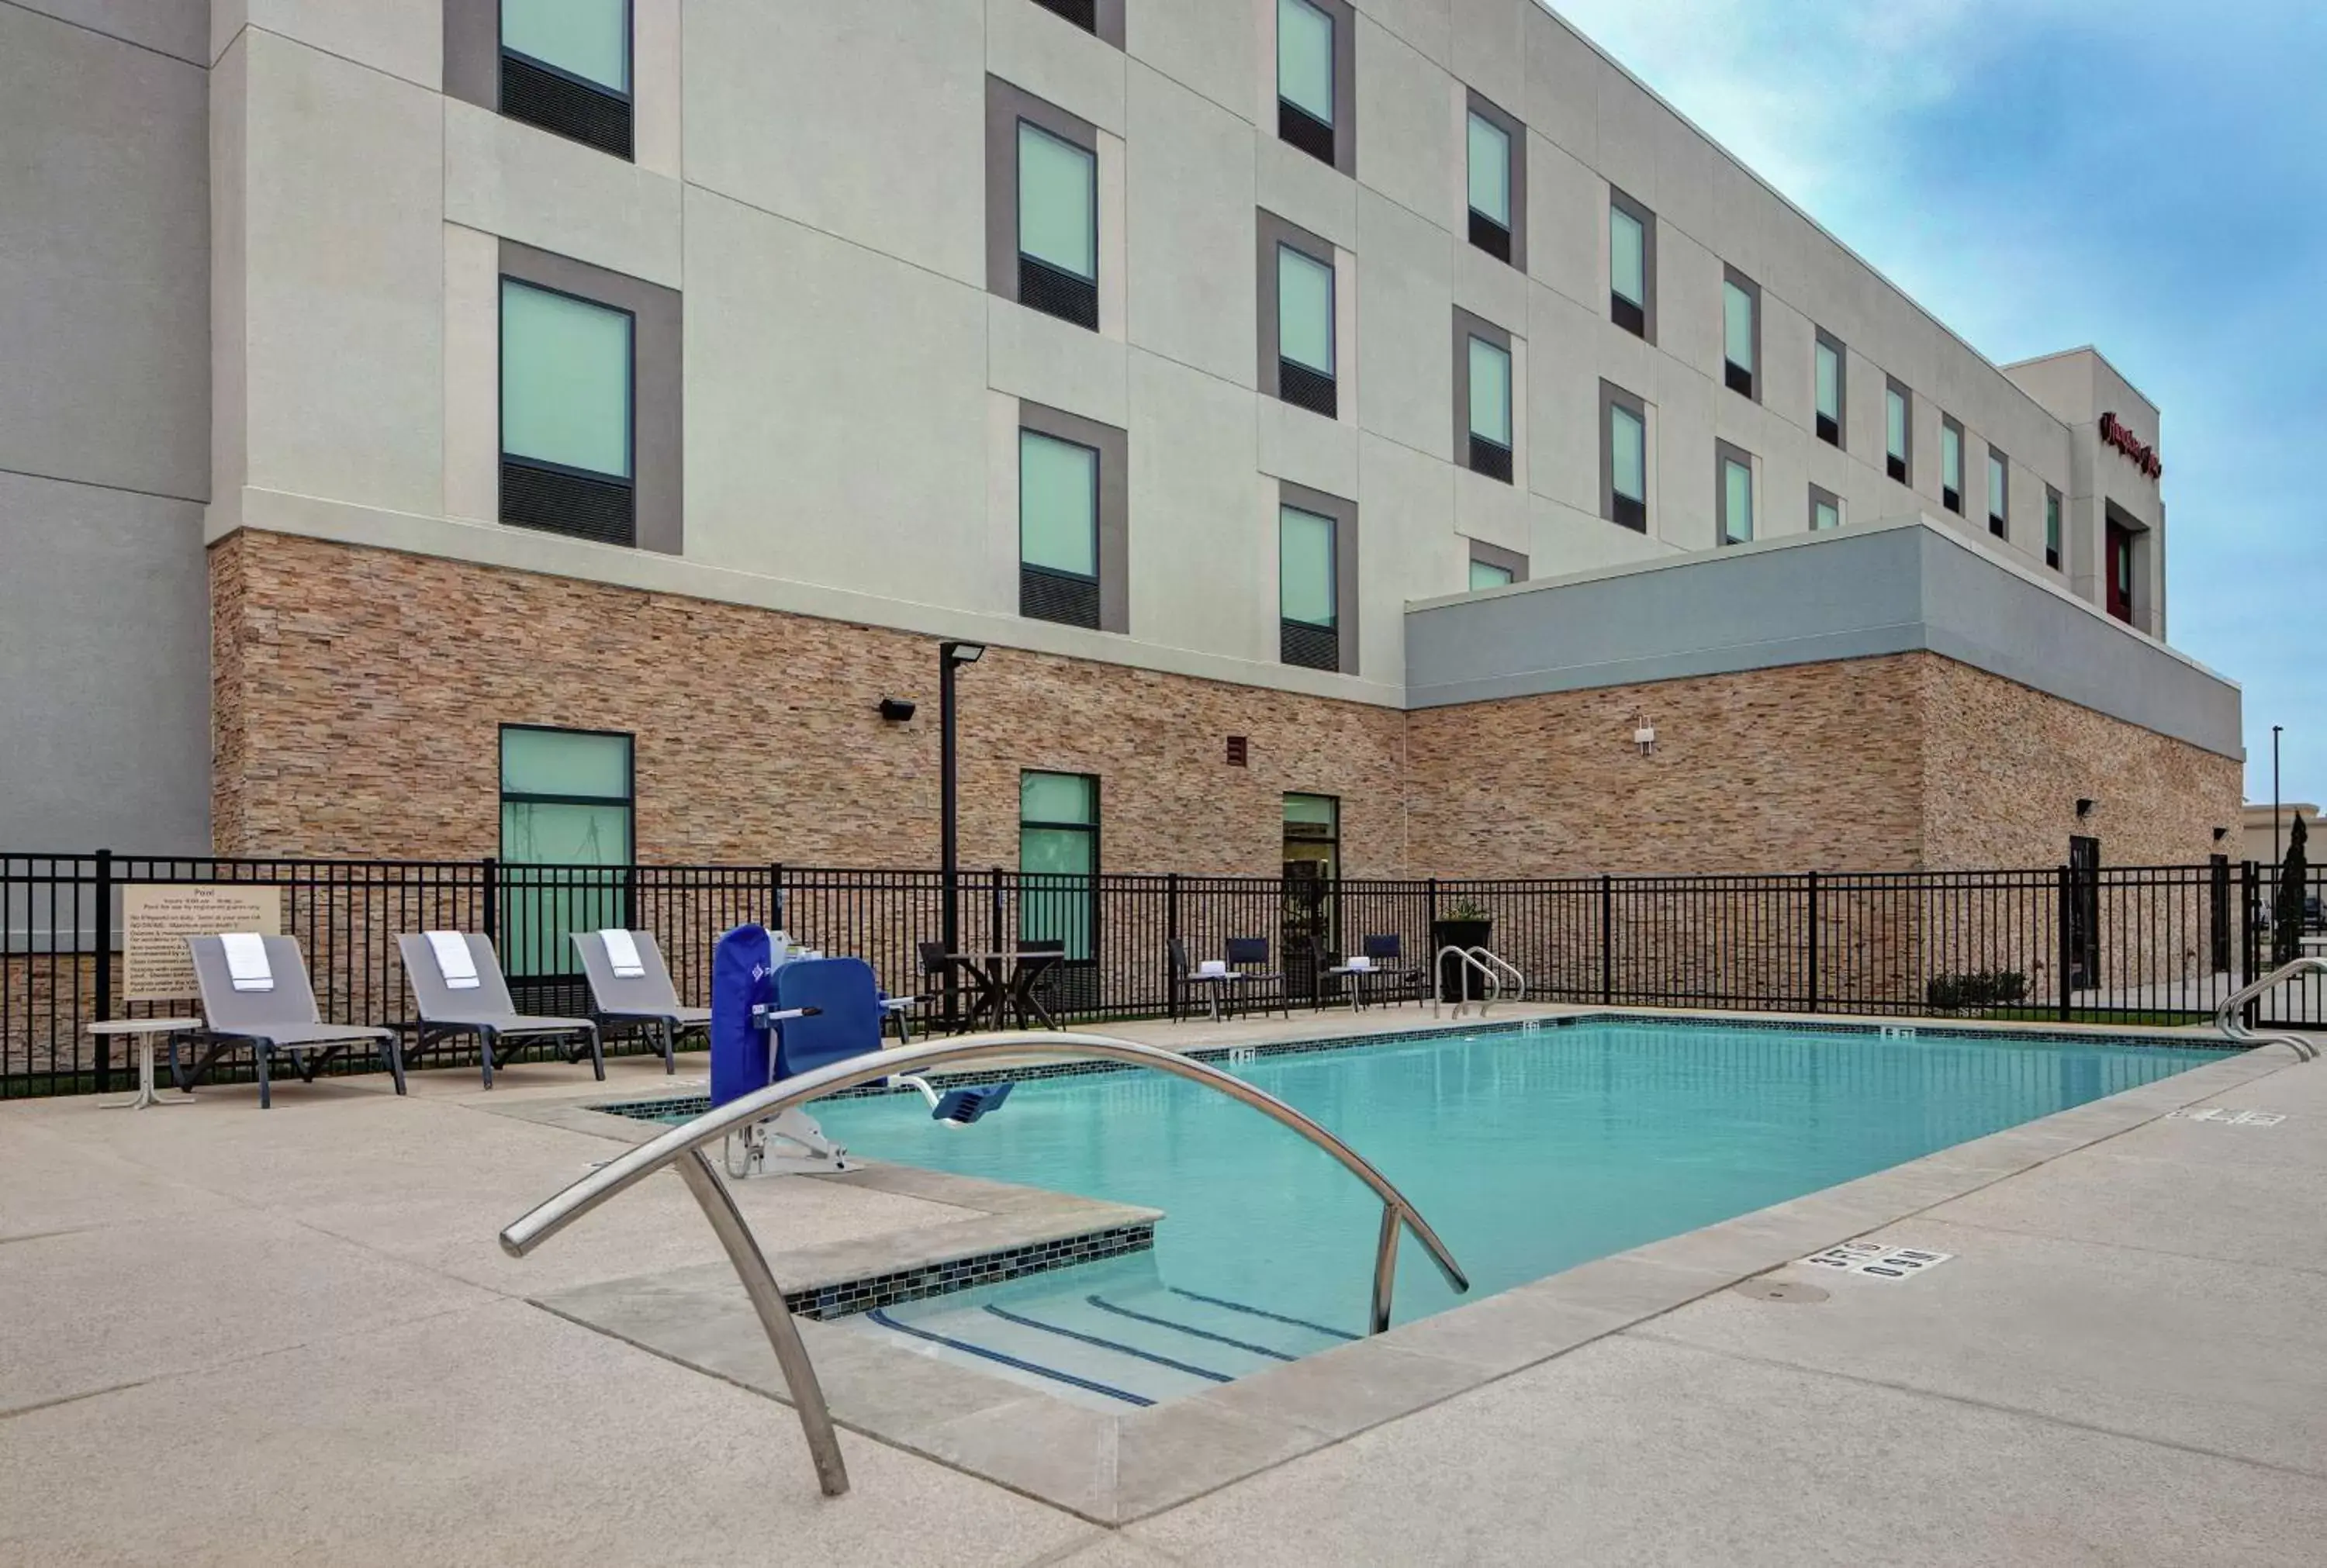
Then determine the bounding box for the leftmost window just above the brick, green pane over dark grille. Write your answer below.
[500,277,638,544]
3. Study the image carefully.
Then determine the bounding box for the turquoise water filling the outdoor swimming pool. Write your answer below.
[814,1021,2220,1349]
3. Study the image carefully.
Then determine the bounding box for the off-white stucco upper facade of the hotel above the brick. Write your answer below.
[209,0,2162,703]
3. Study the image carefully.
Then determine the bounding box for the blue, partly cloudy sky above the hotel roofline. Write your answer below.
[1552,0,2327,800]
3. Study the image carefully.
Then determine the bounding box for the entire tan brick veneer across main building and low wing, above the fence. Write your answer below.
[212,530,2241,877]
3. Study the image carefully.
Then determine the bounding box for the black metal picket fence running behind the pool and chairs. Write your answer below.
[0,854,2327,1098]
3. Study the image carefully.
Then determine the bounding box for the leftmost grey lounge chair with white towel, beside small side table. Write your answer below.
[170,933,405,1110]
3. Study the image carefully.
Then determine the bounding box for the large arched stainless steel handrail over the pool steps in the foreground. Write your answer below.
[500,1033,1471,1496]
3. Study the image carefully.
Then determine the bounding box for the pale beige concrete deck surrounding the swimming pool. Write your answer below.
[0,1010,2327,1566]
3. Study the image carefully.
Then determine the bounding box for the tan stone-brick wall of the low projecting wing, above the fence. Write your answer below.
[1408,654,2241,877]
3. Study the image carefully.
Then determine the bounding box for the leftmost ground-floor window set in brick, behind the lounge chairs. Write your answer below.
[498,724,635,979]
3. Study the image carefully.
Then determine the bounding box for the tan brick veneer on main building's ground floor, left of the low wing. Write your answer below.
[209,530,1403,875]
